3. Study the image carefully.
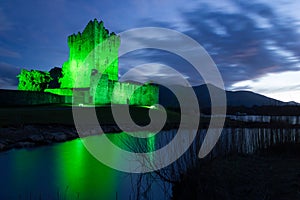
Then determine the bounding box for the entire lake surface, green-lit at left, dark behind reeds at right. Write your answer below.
[0,124,300,199]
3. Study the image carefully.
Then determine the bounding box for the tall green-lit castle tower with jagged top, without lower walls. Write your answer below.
[60,19,120,88]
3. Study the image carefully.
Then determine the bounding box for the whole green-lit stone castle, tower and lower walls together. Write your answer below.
[44,19,159,105]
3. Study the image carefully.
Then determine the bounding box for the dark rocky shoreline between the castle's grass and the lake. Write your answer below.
[0,124,177,152]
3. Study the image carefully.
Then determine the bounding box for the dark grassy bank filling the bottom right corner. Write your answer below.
[173,144,300,200]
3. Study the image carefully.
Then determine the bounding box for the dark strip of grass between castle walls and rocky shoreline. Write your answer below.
[0,105,180,127]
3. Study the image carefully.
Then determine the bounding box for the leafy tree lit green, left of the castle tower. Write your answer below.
[17,69,52,91]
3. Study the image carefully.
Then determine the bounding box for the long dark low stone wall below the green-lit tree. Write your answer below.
[0,90,72,107]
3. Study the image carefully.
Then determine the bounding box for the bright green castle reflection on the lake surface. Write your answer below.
[56,136,118,199]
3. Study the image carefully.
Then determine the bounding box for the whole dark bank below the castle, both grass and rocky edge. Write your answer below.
[0,105,180,151]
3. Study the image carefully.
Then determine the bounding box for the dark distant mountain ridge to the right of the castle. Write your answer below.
[159,84,299,108]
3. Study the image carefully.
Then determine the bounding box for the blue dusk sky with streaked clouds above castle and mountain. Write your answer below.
[0,0,300,102]
